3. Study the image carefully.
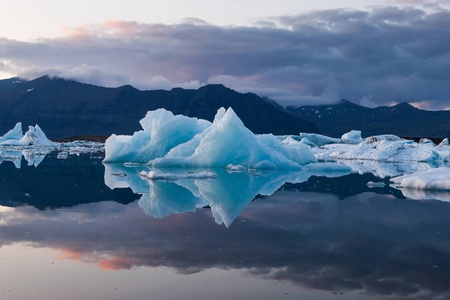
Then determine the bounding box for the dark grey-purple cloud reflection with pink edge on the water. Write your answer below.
[0,191,450,299]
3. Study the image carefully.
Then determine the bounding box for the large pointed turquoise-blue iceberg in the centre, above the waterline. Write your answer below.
[104,108,316,169]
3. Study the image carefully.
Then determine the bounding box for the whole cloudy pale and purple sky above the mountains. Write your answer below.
[0,0,450,110]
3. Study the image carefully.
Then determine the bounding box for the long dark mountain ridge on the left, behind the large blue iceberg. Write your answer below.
[0,76,318,138]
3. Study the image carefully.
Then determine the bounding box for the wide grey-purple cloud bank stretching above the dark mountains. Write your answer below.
[0,7,450,108]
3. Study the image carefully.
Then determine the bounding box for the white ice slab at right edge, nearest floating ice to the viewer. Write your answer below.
[391,167,450,190]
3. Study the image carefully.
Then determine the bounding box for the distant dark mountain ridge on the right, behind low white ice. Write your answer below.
[286,100,450,139]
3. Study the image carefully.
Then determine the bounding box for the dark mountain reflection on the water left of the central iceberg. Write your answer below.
[0,152,137,209]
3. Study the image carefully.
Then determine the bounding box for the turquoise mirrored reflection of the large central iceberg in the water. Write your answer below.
[105,163,350,227]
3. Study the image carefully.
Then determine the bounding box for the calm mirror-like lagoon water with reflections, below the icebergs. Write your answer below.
[0,153,450,300]
